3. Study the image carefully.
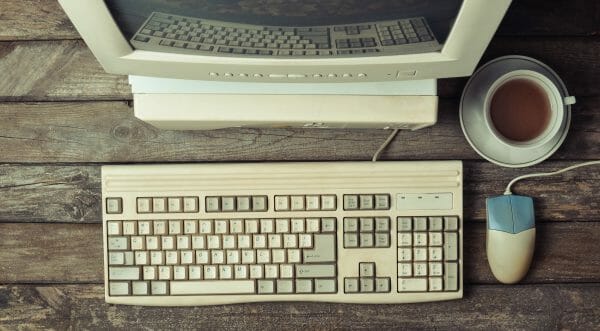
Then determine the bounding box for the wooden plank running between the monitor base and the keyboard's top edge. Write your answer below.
[0,97,600,163]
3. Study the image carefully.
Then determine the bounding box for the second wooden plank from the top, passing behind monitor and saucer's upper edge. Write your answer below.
[0,37,600,101]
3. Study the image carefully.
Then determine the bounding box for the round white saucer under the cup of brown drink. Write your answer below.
[459,55,571,168]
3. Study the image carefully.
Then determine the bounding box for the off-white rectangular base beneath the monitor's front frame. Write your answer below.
[130,77,438,130]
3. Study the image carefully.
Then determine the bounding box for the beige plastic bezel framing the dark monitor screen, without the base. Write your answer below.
[59,0,511,83]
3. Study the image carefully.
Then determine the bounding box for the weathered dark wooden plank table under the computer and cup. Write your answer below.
[0,0,600,329]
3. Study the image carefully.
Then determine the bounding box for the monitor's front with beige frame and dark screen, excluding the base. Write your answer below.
[58,0,511,83]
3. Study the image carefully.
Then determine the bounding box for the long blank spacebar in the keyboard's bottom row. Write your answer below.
[171,280,255,295]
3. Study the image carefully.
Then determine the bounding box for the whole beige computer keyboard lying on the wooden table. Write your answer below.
[102,161,463,306]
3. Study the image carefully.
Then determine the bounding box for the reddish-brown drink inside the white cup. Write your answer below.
[490,79,552,142]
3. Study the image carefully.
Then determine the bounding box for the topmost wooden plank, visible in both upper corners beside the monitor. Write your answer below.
[0,0,600,40]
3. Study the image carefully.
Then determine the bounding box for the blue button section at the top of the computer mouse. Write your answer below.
[486,194,535,234]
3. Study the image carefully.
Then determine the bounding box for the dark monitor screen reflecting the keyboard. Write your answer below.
[105,0,463,57]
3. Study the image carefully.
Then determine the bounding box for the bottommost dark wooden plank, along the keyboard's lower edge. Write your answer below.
[0,284,600,330]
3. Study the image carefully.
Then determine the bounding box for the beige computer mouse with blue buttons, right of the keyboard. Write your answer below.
[486,194,535,284]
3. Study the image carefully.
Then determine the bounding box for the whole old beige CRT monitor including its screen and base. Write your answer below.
[59,0,510,129]
